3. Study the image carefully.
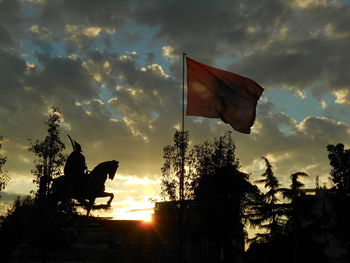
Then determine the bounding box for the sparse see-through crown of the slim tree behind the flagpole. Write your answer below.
[161,130,192,201]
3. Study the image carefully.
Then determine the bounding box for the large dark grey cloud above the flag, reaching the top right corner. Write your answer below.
[131,0,350,103]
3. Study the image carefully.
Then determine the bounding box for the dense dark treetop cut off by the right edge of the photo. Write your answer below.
[327,143,350,192]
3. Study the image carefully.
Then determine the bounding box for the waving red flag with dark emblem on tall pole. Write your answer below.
[186,57,264,134]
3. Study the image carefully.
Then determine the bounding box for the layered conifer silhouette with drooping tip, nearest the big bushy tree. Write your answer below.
[254,157,285,242]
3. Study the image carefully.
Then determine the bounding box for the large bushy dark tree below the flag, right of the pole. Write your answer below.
[188,132,259,262]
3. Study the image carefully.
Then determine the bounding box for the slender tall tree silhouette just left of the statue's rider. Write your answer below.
[29,107,66,199]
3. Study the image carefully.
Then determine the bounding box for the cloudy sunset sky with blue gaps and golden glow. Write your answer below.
[0,0,350,219]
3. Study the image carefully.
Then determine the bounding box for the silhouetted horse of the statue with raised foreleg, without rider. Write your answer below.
[51,160,119,216]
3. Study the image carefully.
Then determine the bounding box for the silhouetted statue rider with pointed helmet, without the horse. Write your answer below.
[64,137,87,196]
